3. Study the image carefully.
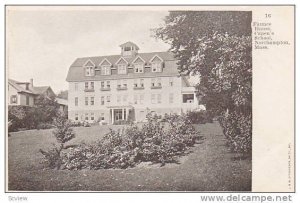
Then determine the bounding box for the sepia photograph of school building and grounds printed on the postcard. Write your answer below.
[5,6,293,192]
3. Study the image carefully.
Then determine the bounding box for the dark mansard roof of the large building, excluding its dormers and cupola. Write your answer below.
[66,52,179,82]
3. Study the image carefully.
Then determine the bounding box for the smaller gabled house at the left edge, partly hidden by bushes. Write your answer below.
[7,79,55,106]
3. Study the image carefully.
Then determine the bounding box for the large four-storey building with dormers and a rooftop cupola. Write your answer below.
[66,42,199,124]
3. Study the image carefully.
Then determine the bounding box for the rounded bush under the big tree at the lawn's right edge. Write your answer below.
[219,111,252,155]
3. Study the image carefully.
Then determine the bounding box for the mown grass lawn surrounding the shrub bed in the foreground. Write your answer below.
[8,123,251,191]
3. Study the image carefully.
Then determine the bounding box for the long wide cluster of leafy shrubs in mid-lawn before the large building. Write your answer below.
[58,115,200,170]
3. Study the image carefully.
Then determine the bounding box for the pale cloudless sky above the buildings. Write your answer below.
[6,7,170,93]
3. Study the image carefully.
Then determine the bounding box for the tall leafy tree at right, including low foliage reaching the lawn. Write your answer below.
[155,11,252,153]
